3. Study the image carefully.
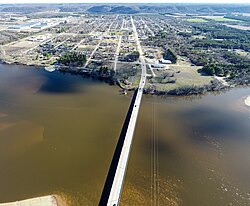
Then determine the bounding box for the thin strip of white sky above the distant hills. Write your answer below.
[0,0,250,4]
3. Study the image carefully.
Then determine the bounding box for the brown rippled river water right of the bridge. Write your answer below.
[121,88,250,206]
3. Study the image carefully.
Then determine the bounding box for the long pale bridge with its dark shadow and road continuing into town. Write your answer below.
[99,17,147,206]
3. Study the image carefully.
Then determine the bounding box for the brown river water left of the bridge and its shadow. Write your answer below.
[0,65,130,206]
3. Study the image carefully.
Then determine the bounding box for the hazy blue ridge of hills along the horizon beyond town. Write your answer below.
[0,3,250,15]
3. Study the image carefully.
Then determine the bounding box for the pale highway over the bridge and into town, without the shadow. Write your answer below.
[103,17,146,206]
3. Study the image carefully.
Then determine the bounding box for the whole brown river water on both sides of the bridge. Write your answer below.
[0,65,250,206]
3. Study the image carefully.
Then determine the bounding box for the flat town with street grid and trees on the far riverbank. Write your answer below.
[0,6,250,95]
